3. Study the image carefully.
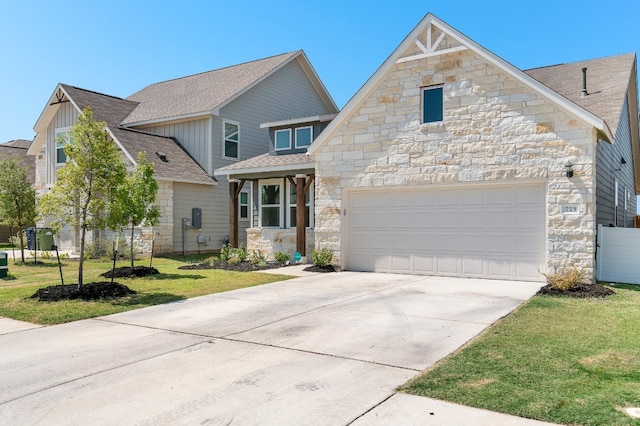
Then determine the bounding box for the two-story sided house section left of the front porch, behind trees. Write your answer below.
[29,51,337,253]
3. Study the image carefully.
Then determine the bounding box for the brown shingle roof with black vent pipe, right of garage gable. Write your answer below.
[524,53,635,136]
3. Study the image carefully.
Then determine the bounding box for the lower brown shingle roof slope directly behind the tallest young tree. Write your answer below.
[61,84,213,184]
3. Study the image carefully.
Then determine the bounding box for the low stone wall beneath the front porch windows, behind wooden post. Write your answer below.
[247,228,315,261]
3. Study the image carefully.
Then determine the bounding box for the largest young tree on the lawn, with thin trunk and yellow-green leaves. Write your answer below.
[41,107,127,291]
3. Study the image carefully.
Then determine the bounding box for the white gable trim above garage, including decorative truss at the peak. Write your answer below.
[308,13,613,154]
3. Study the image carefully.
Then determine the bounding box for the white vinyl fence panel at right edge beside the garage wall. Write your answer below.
[596,225,640,284]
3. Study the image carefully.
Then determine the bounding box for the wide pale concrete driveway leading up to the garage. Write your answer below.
[0,272,552,425]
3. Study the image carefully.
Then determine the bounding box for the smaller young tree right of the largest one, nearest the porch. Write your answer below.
[110,152,160,270]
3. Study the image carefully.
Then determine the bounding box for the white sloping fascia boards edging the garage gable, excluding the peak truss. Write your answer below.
[307,13,613,154]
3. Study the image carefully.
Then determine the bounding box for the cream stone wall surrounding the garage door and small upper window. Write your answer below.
[315,50,597,277]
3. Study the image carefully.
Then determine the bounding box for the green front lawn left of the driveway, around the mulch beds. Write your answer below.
[0,257,291,324]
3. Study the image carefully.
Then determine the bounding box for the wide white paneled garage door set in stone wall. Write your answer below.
[345,185,546,281]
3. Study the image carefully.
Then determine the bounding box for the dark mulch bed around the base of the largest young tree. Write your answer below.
[31,281,136,302]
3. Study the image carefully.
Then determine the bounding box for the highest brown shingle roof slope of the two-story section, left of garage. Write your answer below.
[122,51,301,126]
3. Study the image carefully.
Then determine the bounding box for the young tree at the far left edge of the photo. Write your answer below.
[0,157,36,263]
